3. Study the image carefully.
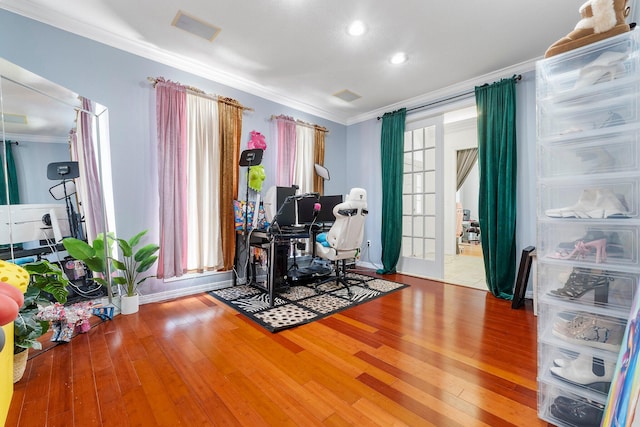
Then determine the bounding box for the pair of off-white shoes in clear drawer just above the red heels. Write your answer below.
[545,188,628,219]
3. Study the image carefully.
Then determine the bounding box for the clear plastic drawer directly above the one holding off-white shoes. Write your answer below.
[538,130,640,178]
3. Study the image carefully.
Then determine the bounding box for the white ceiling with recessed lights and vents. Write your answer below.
[0,0,584,124]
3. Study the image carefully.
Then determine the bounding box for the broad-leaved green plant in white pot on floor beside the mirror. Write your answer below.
[62,230,160,314]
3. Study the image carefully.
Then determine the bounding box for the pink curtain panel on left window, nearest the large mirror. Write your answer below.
[156,79,187,278]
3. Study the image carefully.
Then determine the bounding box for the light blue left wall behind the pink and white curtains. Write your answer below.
[0,10,347,294]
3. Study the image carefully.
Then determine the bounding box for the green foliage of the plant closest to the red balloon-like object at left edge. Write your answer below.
[13,260,69,354]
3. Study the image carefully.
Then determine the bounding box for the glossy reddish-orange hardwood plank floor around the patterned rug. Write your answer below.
[6,275,547,427]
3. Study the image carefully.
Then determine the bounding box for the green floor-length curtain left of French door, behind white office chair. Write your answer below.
[378,108,407,274]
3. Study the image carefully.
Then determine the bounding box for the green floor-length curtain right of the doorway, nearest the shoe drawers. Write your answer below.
[475,78,517,300]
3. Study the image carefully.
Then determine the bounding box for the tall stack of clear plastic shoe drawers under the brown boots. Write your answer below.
[536,31,640,426]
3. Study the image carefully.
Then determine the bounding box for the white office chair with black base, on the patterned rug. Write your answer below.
[316,188,368,296]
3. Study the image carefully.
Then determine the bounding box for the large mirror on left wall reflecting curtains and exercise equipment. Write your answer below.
[0,58,115,296]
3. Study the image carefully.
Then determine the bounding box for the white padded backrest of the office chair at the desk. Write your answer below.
[327,188,368,251]
